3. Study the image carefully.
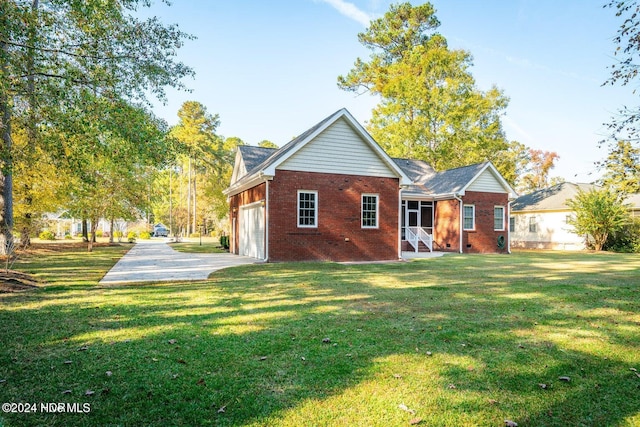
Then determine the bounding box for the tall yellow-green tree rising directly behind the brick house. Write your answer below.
[338,3,516,172]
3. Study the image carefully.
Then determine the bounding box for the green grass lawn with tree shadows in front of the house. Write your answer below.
[0,248,640,426]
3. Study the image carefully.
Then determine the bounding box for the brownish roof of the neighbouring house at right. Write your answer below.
[511,182,597,212]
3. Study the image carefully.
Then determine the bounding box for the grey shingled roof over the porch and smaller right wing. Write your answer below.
[393,159,516,198]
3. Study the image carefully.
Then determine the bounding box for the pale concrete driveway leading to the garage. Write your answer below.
[100,239,258,284]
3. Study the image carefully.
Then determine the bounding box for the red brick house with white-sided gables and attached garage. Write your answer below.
[225,109,515,261]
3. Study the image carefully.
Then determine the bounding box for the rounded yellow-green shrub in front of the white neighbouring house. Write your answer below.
[567,188,630,251]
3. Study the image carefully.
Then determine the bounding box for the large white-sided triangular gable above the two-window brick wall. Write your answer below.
[277,118,397,178]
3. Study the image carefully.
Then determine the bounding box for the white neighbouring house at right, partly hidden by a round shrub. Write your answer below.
[509,182,640,250]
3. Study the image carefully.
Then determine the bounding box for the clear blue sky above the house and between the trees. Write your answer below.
[147,0,637,182]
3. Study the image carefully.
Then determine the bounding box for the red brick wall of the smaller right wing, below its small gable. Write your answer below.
[462,191,509,253]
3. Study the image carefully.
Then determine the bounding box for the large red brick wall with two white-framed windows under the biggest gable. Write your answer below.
[268,170,399,261]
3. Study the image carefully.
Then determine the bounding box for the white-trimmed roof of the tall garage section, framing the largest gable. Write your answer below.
[224,108,411,195]
